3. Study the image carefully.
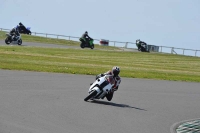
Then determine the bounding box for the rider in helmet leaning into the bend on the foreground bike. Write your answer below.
[96,66,121,101]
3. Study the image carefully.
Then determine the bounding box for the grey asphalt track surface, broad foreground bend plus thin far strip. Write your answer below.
[0,42,200,133]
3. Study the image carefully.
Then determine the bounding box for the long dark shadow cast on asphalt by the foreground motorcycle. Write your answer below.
[90,100,147,111]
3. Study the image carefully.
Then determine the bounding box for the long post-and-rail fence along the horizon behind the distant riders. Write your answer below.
[0,28,200,57]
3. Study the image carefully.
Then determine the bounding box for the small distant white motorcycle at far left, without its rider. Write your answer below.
[5,33,22,45]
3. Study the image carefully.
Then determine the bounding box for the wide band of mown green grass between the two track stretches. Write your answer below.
[0,45,200,82]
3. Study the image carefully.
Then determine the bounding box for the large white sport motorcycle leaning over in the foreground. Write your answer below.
[84,75,115,101]
